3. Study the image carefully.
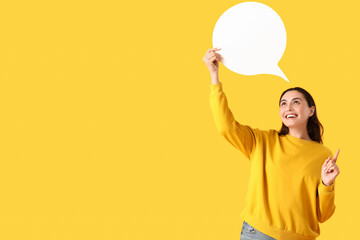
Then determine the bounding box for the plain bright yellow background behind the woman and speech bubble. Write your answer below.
[0,0,360,240]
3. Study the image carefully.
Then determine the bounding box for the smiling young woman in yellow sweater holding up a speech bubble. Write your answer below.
[203,48,340,240]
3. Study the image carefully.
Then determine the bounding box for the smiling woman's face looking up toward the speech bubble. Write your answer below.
[279,90,315,129]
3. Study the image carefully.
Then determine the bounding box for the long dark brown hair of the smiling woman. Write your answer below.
[278,87,324,144]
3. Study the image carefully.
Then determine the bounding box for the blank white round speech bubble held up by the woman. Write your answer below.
[212,2,289,82]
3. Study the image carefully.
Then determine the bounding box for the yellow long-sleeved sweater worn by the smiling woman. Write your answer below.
[210,82,335,240]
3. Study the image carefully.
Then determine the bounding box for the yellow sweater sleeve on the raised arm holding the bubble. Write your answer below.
[210,82,257,160]
